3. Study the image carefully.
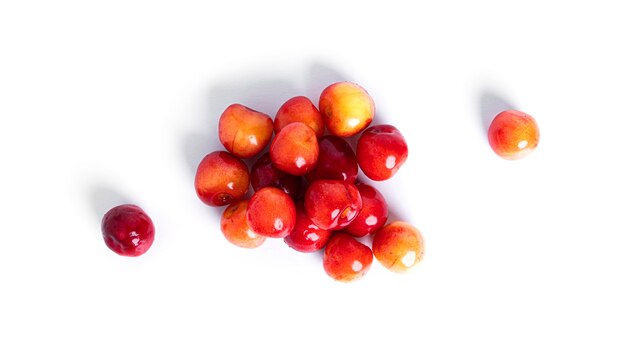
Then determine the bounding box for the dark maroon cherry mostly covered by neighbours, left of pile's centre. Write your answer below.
[250,153,302,199]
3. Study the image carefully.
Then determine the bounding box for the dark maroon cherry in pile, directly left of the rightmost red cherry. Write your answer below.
[306,135,359,183]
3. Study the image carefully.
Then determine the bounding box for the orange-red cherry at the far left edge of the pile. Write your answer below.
[195,151,250,207]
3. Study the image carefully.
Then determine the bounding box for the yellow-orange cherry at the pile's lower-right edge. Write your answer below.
[372,221,424,273]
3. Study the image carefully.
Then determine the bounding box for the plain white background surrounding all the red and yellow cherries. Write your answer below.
[0,1,626,351]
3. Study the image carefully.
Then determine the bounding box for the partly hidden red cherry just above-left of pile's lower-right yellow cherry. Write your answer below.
[345,183,389,237]
